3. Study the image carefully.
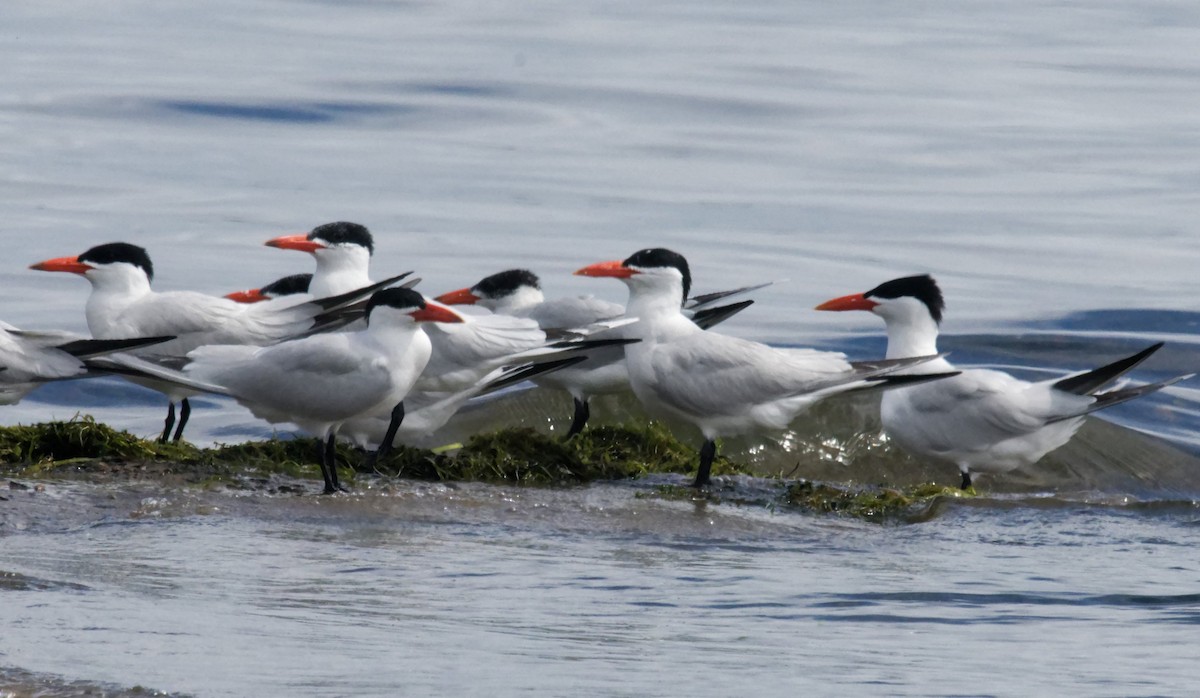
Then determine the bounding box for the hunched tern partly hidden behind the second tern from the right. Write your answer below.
[437,269,766,439]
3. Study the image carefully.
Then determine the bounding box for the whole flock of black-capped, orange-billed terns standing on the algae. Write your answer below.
[0,222,1190,494]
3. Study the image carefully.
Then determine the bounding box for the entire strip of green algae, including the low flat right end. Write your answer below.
[0,416,974,522]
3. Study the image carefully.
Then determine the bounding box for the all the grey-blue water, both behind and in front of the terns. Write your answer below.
[0,0,1200,696]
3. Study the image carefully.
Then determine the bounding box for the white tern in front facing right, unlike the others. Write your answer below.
[184,288,462,494]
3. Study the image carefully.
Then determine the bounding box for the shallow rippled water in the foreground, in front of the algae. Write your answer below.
[0,482,1200,696]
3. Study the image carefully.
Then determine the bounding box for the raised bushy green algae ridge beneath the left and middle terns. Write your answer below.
[0,416,746,485]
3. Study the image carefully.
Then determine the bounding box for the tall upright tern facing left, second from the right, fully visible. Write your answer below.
[575,247,930,487]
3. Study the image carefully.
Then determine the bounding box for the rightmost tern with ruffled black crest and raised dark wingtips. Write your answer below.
[816,275,1188,489]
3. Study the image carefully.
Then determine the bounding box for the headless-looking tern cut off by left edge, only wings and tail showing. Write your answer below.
[0,321,173,404]
